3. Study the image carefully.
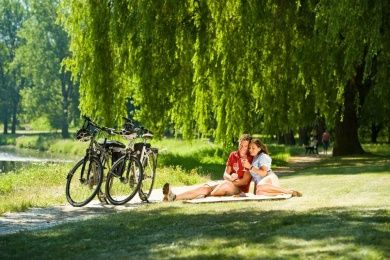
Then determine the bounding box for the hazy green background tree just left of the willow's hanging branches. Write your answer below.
[13,0,78,137]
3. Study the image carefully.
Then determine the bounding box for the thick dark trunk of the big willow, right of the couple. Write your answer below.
[333,77,364,156]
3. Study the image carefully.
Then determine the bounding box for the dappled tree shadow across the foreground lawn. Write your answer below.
[0,204,390,259]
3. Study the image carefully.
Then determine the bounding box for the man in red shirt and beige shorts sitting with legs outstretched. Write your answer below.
[163,134,253,201]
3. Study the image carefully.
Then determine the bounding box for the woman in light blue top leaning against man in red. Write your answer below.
[243,139,302,197]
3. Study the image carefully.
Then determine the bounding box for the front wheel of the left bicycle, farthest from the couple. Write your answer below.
[66,157,103,207]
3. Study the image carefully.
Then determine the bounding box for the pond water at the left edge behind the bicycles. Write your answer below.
[0,146,73,174]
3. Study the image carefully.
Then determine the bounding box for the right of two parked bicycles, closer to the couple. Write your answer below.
[106,118,158,205]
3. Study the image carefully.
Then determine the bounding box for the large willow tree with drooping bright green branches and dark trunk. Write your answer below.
[61,0,389,155]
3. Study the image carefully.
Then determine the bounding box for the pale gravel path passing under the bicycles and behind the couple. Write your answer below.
[0,155,327,236]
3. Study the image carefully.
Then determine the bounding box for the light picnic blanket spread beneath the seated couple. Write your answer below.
[184,193,292,204]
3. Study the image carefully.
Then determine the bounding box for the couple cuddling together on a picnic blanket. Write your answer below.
[163,134,302,201]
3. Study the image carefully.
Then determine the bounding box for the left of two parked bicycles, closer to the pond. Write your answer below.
[65,117,126,207]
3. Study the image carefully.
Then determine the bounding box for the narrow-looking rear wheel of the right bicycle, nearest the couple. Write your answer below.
[138,150,157,201]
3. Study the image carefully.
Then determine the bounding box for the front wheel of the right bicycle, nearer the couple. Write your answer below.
[106,155,143,205]
